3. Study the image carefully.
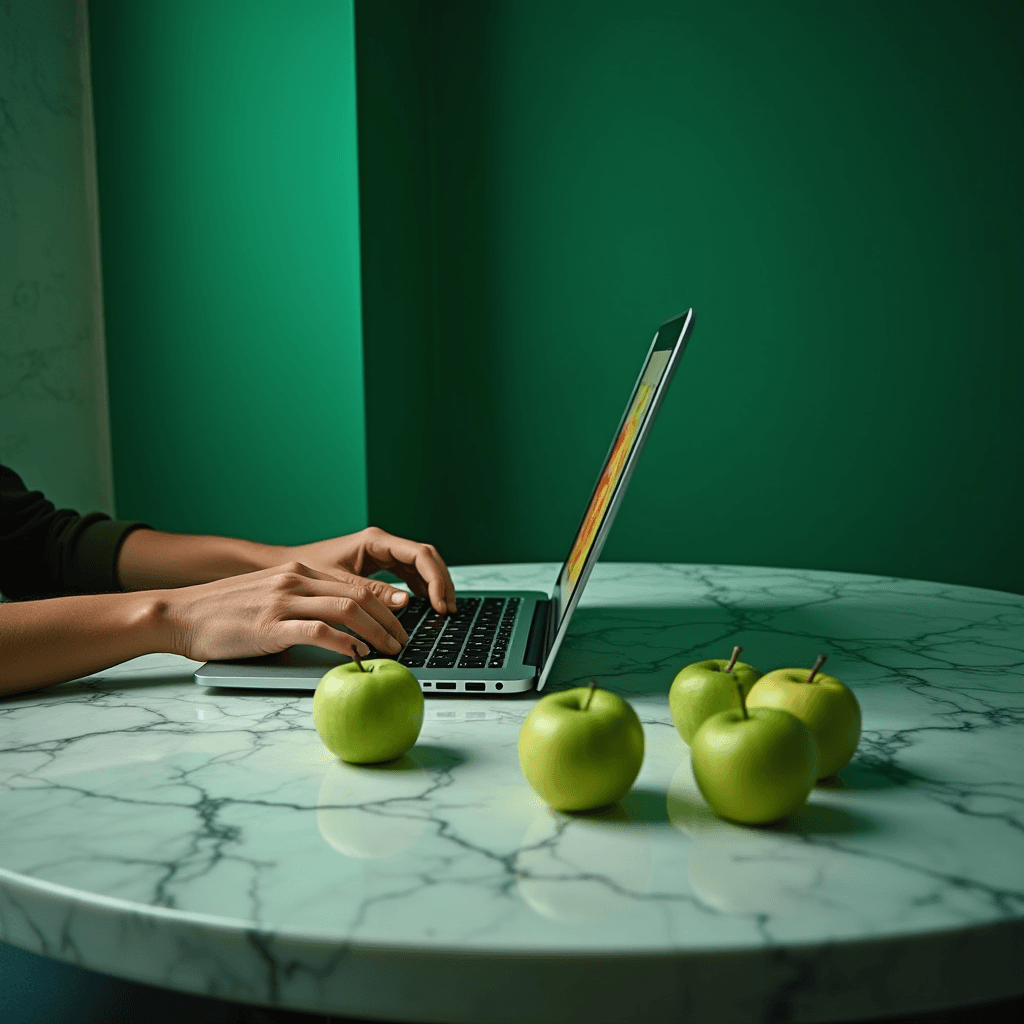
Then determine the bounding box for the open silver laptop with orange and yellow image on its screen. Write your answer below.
[195,309,693,695]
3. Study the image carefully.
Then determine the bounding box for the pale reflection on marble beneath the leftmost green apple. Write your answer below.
[316,754,429,860]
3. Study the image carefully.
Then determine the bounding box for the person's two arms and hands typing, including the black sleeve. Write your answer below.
[0,466,444,696]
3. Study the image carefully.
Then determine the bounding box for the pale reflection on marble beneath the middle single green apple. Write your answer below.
[516,804,651,922]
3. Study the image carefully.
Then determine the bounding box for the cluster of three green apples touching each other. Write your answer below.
[669,647,861,824]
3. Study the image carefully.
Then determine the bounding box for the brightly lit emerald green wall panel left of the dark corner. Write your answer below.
[89,0,367,543]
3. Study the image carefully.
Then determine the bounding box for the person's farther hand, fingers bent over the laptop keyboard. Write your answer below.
[285,526,456,615]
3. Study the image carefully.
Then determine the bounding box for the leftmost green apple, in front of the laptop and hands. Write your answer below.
[313,657,423,765]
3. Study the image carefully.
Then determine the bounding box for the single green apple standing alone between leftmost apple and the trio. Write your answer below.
[519,683,643,811]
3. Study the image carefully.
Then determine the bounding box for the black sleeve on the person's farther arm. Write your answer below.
[0,466,148,600]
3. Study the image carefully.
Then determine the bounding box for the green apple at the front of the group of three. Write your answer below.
[690,683,818,824]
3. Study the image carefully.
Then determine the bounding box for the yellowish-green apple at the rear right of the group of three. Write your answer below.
[746,654,861,778]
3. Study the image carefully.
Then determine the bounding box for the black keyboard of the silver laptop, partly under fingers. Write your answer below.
[372,597,522,669]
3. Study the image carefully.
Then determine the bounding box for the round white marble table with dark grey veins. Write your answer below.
[0,564,1024,1024]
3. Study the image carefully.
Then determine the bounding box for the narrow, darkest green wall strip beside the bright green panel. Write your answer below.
[355,0,438,541]
